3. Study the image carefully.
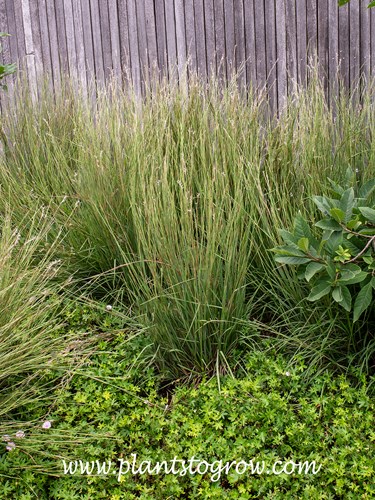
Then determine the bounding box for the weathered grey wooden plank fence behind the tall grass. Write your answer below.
[0,0,375,107]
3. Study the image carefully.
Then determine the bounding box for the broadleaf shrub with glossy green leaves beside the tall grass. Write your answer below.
[271,168,375,323]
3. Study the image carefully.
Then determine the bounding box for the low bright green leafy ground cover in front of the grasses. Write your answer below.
[0,344,375,500]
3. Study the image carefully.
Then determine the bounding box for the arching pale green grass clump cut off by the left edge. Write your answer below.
[0,207,85,426]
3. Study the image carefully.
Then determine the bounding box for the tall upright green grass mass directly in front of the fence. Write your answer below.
[0,68,375,378]
